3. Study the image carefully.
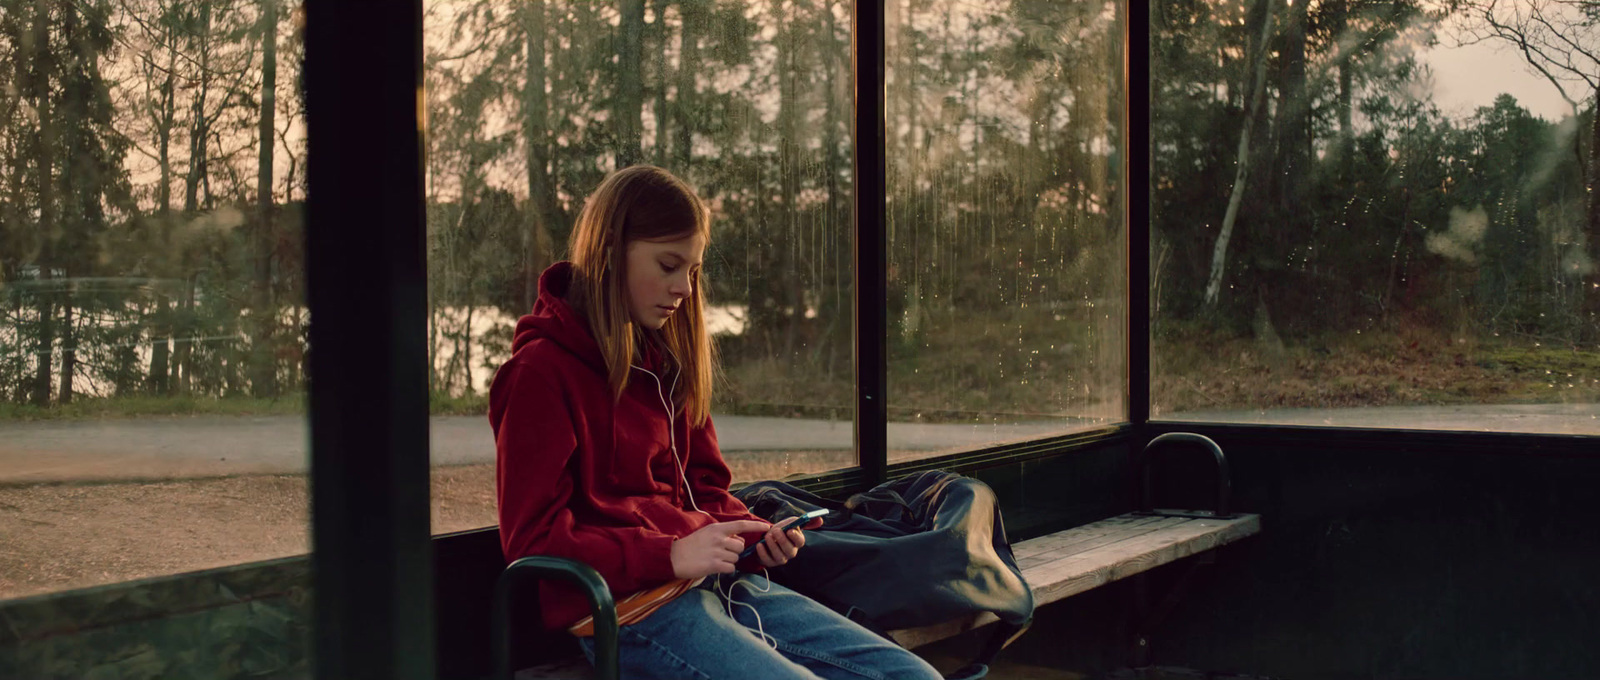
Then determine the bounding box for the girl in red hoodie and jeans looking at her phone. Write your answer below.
[490,165,939,680]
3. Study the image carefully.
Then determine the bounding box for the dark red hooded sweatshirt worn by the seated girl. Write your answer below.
[490,262,762,629]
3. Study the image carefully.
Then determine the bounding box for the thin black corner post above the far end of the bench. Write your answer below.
[1122,0,1154,432]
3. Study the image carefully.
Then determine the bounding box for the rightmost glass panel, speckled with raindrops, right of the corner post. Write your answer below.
[1150,0,1600,434]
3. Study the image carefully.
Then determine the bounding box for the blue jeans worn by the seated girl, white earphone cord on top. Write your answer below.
[578,573,941,680]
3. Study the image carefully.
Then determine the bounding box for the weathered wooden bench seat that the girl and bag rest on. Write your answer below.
[517,510,1261,680]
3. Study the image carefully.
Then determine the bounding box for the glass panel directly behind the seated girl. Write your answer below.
[424,0,854,531]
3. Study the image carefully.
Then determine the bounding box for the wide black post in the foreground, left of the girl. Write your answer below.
[304,0,435,680]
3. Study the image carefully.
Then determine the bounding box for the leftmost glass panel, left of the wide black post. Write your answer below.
[0,0,309,598]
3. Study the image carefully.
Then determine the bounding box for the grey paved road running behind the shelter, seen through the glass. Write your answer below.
[0,405,1600,483]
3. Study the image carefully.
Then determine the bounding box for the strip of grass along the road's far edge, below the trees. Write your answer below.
[0,307,1600,422]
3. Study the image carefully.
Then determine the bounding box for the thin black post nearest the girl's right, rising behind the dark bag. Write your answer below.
[850,0,890,486]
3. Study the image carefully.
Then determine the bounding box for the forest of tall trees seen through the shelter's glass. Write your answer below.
[0,0,1600,421]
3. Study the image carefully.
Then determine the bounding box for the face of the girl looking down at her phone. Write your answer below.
[627,234,706,330]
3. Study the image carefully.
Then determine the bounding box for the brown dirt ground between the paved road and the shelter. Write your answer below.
[0,464,494,600]
